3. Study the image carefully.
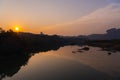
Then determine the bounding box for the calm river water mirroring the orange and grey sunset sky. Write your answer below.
[0,46,120,80]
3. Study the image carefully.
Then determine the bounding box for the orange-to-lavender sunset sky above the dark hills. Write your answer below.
[0,0,120,35]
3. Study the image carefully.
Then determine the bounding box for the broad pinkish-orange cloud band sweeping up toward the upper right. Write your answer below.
[43,4,120,35]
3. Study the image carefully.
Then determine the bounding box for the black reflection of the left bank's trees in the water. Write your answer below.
[0,46,60,80]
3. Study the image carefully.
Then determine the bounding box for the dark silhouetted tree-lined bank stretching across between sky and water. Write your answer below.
[0,29,120,57]
